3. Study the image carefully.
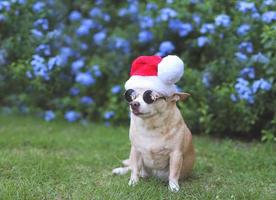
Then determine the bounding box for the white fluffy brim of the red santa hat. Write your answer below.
[125,75,177,96]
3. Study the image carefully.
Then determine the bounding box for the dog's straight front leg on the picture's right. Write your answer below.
[169,151,183,192]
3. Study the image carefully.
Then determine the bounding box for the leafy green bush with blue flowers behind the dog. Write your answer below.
[0,0,276,140]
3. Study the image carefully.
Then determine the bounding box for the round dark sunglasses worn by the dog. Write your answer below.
[124,89,167,104]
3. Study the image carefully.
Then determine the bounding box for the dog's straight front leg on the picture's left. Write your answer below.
[128,147,142,186]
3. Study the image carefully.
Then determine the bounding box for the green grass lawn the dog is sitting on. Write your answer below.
[0,116,276,200]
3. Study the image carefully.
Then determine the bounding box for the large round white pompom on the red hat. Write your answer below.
[158,55,184,85]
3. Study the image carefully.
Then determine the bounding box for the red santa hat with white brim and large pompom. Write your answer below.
[125,55,184,96]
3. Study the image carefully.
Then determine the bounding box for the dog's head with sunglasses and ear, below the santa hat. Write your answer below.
[124,89,190,118]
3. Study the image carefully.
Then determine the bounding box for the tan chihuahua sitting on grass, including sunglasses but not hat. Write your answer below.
[112,88,195,192]
